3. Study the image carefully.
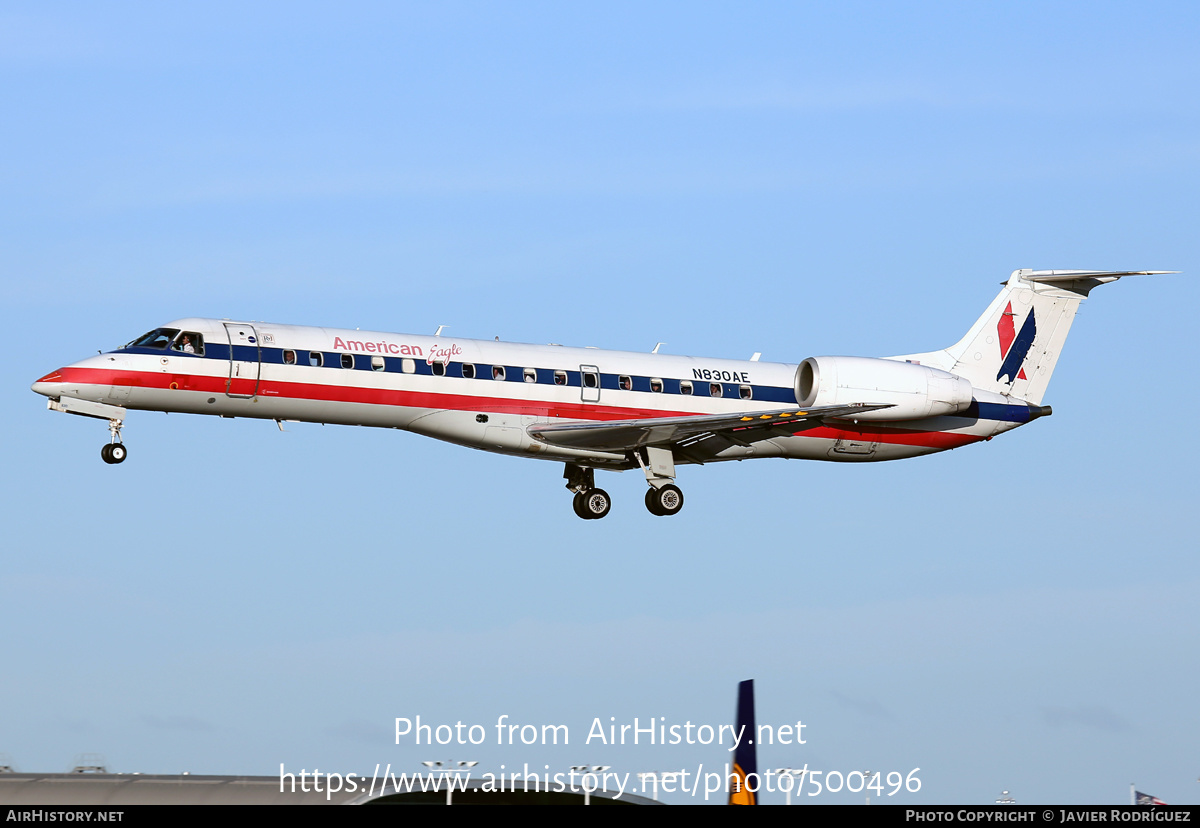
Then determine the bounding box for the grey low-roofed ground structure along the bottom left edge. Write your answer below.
[0,773,660,808]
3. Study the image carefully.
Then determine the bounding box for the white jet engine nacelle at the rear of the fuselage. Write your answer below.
[796,356,972,421]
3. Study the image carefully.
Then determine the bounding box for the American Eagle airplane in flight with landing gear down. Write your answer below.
[32,270,1177,520]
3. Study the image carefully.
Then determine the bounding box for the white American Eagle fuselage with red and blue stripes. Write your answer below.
[34,318,1020,468]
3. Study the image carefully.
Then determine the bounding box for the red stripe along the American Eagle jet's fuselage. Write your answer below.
[47,367,984,449]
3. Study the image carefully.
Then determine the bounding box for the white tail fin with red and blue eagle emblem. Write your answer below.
[894,270,1177,406]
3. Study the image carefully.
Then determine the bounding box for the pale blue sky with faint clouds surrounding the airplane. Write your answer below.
[0,2,1200,804]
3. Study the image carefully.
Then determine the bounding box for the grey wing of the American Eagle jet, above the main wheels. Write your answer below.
[528,404,892,454]
